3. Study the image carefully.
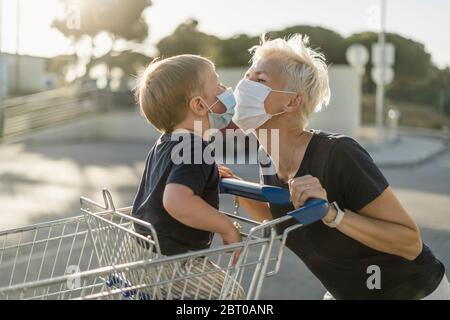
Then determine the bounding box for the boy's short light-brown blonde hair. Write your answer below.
[136,54,214,132]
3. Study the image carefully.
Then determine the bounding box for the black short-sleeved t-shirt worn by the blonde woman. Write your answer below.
[261,131,445,299]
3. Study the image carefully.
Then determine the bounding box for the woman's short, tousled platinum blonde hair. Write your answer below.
[250,34,330,125]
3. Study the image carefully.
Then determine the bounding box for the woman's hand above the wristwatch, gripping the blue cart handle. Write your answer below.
[289,175,337,223]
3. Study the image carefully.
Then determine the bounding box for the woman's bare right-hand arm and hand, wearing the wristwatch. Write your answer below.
[289,176,422,260]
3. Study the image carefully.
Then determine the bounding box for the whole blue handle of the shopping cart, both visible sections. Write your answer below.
[219,178,329,225]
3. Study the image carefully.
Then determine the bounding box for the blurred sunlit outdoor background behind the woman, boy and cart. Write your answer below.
[0,0,450,299]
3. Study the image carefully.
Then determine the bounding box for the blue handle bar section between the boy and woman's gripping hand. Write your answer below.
[219,178,291,204]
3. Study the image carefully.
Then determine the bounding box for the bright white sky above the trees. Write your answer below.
[0,0,450,67]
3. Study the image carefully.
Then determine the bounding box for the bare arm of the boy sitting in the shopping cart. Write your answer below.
[163,183,241,244]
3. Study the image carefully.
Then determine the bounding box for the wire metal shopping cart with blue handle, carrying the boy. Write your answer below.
[0,179,328,300]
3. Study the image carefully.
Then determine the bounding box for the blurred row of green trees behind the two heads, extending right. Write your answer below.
[157,20,450,121]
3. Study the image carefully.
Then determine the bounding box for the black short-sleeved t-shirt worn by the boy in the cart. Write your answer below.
[132,133,219,255]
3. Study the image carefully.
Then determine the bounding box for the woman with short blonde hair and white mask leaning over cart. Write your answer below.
[220,35,450,299]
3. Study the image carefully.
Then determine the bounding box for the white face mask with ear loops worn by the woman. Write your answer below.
[233,79,297,134]
